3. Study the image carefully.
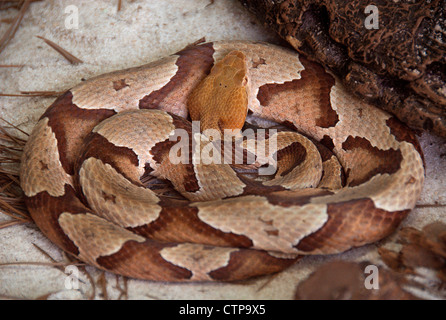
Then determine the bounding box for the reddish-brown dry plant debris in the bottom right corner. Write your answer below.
[295,222,446,300]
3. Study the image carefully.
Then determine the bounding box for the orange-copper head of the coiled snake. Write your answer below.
[187,51,248,134]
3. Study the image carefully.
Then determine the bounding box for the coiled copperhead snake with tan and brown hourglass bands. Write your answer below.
[20,41,424,282]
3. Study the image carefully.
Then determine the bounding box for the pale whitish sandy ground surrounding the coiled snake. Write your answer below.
[0,0,446,299]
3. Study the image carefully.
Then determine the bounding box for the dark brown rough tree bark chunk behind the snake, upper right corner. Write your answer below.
[240,0,446,138]
